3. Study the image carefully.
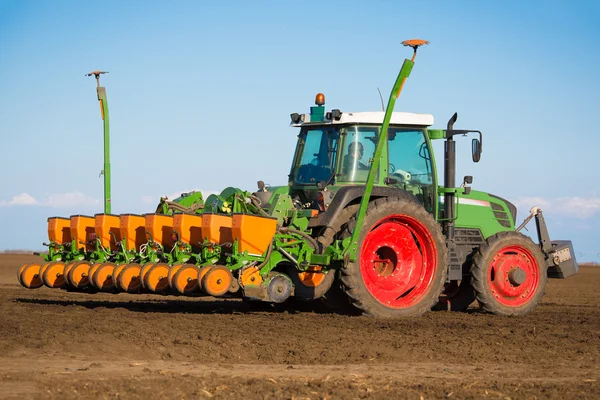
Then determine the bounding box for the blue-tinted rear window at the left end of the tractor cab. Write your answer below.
[290,126,340,185]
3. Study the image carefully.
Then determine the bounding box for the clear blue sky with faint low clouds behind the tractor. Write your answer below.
[0,0,600,261]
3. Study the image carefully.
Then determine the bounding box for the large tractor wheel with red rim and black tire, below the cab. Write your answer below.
[341,197,448,317]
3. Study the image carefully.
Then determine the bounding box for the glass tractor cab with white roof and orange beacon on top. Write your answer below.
[289,94,437,211]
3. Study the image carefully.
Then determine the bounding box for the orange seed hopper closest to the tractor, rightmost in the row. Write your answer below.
[231,214,277,255]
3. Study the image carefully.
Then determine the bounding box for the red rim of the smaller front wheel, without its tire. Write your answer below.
[488,246,540,307]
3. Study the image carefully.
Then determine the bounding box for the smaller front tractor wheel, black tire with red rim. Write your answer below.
[471,232,548,316]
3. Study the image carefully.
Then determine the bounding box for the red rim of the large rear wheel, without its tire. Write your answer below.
[360,215,437,308]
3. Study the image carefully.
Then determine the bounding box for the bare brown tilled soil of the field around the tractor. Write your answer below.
[0,255,600,399]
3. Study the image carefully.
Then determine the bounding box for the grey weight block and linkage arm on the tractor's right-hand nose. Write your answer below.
[517,207,579,279]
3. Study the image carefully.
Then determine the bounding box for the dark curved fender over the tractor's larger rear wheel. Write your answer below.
[308,185,419,228]
